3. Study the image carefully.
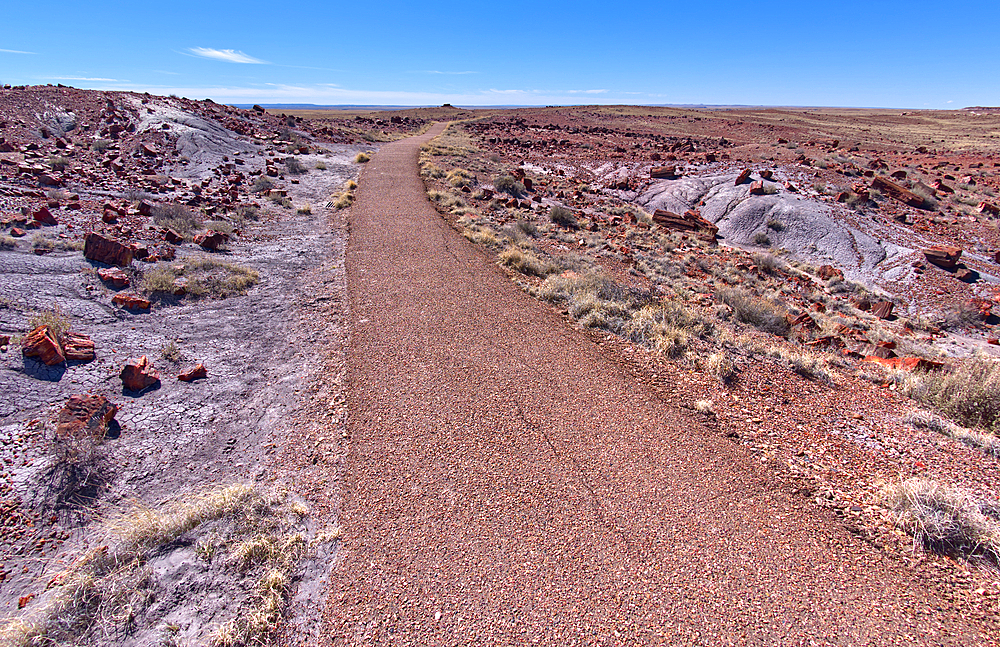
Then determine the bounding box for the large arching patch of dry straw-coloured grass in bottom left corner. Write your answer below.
[0,484,316,647]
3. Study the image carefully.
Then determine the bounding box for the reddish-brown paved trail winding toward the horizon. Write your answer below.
[326,126,992,645]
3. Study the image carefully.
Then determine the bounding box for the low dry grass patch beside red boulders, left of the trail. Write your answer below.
[142,258,260,299]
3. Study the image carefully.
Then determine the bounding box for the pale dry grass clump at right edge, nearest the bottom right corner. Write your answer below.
[883,478,1000,565]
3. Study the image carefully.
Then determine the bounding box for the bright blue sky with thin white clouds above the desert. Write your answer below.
[0,0,1000,109]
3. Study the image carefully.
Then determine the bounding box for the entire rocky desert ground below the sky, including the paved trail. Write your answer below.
[0,86,1000,645]
